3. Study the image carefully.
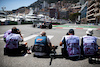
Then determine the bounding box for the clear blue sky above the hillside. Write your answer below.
[0,0,37,11]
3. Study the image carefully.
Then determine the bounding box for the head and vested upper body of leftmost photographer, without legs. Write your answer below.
[5,27,23,49]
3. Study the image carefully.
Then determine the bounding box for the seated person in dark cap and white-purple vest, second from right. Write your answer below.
[60,29,80,58]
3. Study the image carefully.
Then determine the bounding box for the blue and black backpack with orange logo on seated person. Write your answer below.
[33,36,47,52]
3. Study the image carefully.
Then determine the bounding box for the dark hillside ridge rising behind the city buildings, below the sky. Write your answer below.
[11,0,79,13]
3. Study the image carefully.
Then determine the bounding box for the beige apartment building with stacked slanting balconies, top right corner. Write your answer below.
[87,0,100,24]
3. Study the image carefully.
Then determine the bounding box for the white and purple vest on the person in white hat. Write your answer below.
[83,36,98,55]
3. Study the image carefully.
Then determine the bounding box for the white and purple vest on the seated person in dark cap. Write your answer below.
[65,35,80,57]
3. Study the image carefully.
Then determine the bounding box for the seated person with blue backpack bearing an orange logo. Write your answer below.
[32,31,54,56]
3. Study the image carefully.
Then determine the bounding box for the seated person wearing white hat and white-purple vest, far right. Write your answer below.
[81,29,98,56]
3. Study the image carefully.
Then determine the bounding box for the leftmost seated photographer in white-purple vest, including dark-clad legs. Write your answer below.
[4,27,31,55]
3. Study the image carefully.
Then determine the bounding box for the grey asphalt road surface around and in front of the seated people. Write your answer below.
[0,24,100,67]
